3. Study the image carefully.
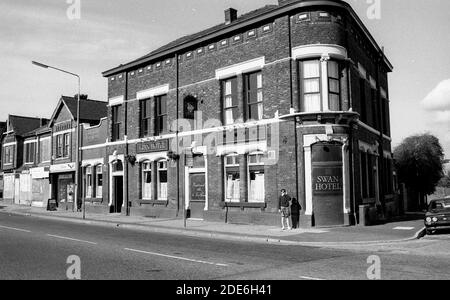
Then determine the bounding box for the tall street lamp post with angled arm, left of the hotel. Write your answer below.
[32,61,86,219]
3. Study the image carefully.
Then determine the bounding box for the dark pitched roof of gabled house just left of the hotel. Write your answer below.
[61,96,108,121]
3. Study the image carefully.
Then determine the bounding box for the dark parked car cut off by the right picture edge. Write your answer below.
[425,198,450,234]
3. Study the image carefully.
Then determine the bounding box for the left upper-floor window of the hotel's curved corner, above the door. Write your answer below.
[300,60,322,112]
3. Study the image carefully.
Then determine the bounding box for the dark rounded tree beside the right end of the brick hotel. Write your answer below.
[394,134,444,195]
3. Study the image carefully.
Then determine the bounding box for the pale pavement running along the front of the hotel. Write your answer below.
[0,200,424,247]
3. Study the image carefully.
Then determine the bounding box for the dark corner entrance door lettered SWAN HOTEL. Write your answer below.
[312,142,345,227]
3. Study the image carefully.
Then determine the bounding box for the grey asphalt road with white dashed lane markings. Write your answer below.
[0,213,450,280]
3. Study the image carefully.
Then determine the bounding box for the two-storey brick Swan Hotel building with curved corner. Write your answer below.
[88,0,399,227]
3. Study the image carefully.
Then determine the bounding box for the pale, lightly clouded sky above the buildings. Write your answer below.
[0,0,450,158]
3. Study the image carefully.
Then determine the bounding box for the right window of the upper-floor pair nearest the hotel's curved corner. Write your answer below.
[244,72,263,120]
